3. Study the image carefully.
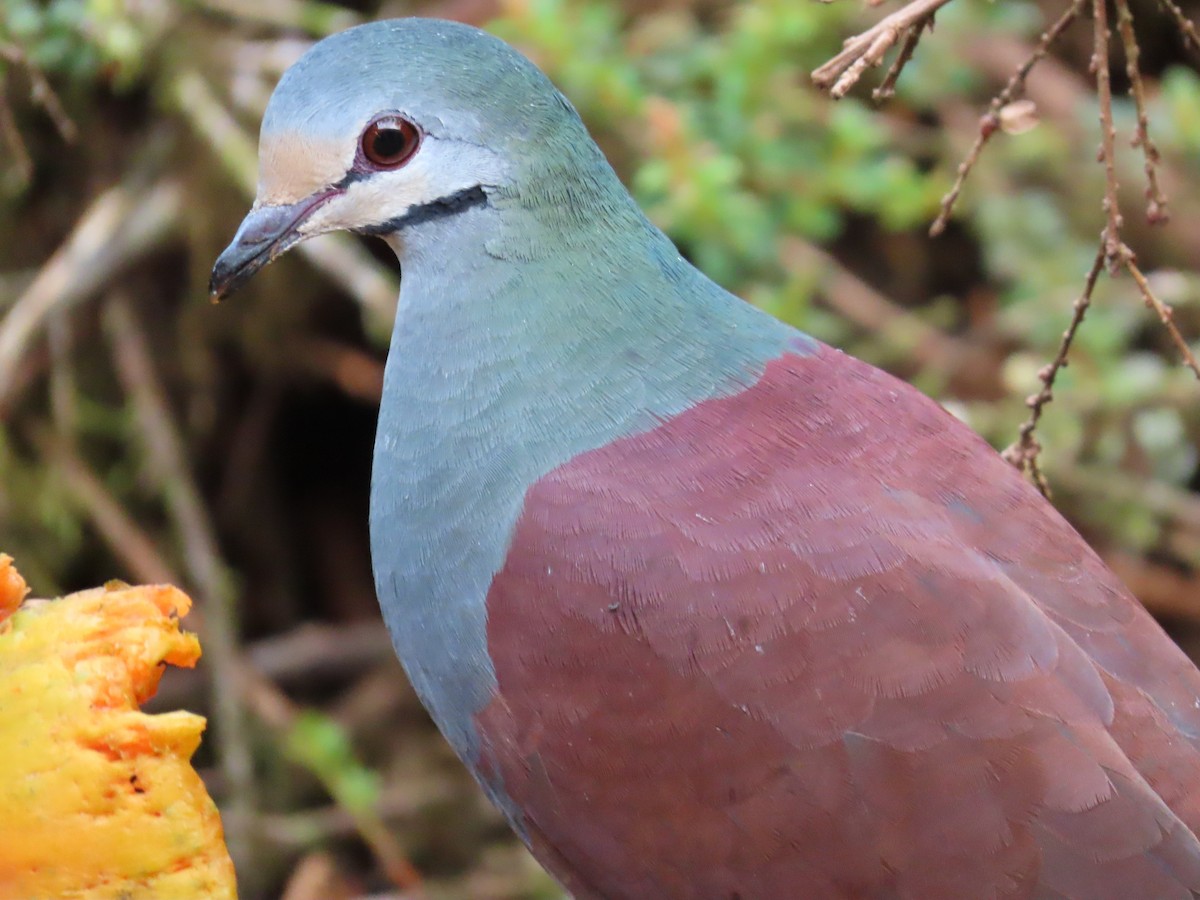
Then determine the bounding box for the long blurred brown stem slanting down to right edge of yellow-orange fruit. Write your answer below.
[104,296,254,864]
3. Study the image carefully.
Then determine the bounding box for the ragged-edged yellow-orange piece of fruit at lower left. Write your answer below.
[0,558,235,900]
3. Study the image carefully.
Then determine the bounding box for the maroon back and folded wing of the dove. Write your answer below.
[476,349,1200,900]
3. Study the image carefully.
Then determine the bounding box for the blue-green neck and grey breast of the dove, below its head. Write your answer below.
[371,187,803,762]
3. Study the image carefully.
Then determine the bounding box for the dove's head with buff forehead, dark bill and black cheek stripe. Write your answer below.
[210,19,590,299]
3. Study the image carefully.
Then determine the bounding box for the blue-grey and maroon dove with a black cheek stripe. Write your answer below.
[210,18,1200,900]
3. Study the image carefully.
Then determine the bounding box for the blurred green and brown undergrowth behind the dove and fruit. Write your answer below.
[0,0,1200,900]
